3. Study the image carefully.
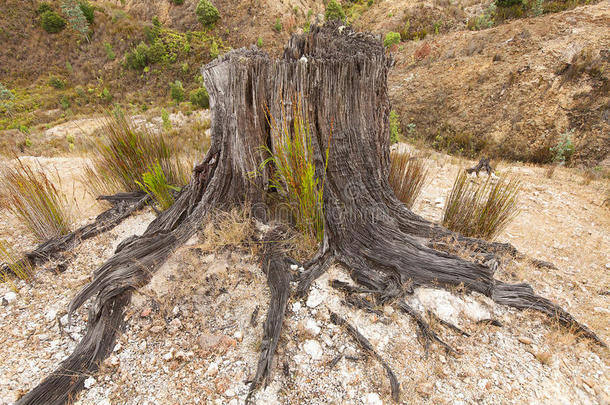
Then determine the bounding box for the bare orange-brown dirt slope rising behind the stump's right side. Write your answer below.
[390,1,610,165]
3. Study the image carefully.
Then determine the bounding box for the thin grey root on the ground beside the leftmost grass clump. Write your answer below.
[0,193,150,274]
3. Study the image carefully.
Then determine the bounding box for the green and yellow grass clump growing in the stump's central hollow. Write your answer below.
[262,100,330,241]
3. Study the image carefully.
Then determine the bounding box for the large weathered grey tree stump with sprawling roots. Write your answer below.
[18,23,603,405]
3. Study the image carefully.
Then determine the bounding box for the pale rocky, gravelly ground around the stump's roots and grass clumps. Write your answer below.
[0,144,610,404]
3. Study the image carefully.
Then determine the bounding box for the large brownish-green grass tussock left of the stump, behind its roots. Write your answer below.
[85,114,190,195]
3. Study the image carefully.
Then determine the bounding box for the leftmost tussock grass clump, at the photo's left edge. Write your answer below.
[0,159,72,241]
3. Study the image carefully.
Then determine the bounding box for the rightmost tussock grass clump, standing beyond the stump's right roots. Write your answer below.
[443,171,521,239]
